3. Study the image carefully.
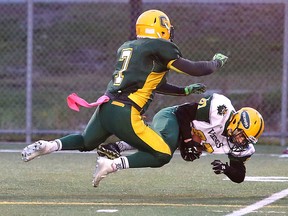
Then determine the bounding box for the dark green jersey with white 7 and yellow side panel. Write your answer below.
[106,38,182,110]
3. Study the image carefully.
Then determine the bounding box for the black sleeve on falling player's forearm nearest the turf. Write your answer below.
[224,156,248,183]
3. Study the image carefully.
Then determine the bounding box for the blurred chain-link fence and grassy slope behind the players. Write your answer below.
[0,0,288,146]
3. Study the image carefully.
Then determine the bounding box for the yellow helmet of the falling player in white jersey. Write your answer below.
[227,107,264,149]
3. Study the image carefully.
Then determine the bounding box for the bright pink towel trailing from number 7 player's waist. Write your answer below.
[67,93,110,112]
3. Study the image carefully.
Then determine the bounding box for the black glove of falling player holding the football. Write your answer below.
[180,140,202,161]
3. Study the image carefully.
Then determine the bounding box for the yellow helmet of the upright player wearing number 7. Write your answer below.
[136,10,174,40]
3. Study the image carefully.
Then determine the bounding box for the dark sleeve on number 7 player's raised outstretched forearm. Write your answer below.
[168,58,220,76]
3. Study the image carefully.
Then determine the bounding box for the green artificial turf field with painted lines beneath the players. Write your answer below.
[0,145,288,216]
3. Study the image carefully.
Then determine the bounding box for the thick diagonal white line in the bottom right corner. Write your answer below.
[225,188,288,216]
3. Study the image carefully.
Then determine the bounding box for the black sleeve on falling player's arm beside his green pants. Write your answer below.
[175,103,198,140]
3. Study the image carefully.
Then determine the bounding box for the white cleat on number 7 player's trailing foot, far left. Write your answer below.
[22,140,52,162]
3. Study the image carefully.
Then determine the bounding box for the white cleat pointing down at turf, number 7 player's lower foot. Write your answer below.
[92,157,118,187]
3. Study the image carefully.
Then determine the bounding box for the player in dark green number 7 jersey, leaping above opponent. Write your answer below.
[22,10,228,186]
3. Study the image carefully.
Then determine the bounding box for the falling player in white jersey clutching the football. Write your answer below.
[97,93,264,183]
